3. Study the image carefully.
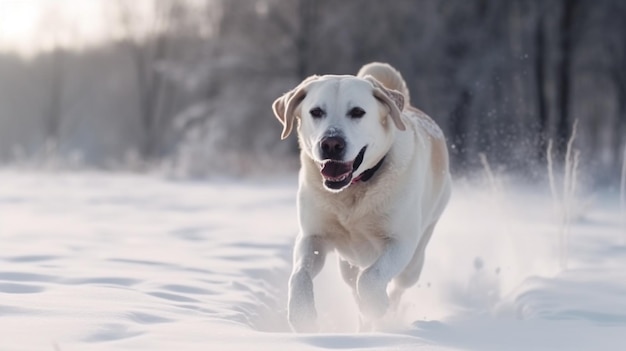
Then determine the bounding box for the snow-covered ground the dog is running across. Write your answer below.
[0,170,626,351]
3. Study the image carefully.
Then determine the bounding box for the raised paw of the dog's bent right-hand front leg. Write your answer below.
[357,270,389,319]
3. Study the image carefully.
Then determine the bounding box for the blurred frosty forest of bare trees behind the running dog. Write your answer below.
[0,0,626,183]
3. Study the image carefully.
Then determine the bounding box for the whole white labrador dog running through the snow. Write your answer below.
[272,63,450,331]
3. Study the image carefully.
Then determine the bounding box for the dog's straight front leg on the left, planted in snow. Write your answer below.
[287,234,326,332]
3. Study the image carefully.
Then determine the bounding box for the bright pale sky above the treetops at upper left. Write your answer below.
[0,0,212,56]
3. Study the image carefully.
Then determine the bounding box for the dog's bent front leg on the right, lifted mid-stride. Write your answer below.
[357,238,414,320]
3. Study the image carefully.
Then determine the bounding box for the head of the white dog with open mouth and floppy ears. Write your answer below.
[272,75,406,192]
